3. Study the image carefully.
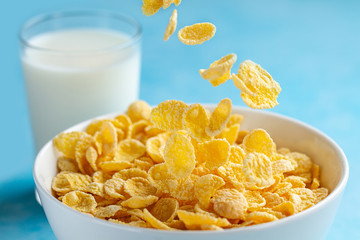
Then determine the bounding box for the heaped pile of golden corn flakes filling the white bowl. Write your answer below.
[52,99,328,230]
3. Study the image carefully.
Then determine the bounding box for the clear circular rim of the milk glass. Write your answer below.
[18,10,142,54]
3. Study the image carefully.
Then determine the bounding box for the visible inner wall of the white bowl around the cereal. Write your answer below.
[34,105,347,204]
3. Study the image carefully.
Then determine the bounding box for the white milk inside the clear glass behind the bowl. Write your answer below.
[22,29,140,151]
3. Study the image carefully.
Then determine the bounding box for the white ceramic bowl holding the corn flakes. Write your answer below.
[33,105,349,240]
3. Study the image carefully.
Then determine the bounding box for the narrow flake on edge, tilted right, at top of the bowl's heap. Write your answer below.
[205,98,232,137]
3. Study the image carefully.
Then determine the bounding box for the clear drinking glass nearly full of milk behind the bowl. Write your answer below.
[20,11,141,151]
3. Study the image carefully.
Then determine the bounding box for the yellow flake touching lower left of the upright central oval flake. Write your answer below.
[148,163,179,193]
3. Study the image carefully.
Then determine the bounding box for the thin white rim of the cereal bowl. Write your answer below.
[33,104,349,235]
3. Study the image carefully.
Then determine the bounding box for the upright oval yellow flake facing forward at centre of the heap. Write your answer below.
[164,133,196,179]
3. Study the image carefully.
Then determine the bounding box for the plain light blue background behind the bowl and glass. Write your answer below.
[0,0,360,240]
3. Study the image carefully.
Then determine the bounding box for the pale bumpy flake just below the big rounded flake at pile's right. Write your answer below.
[243,152,275,190]
